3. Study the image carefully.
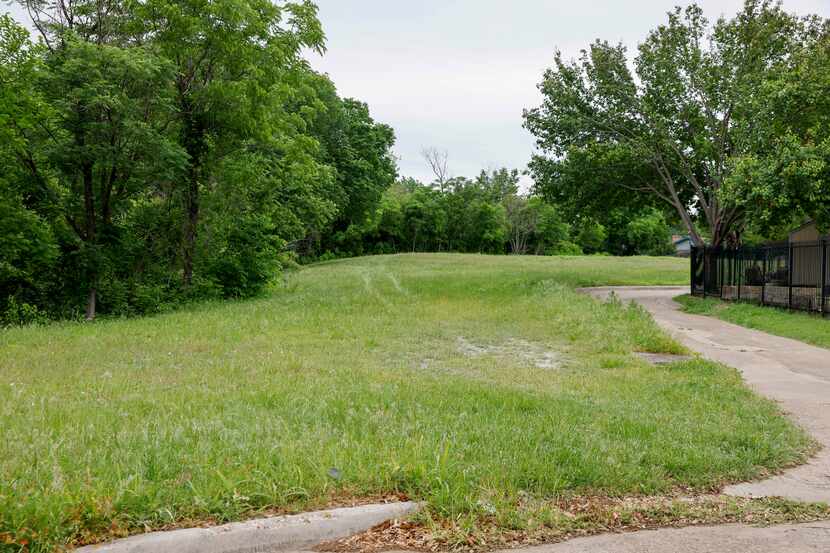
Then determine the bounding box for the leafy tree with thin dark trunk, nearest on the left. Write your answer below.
[51,40,184,319]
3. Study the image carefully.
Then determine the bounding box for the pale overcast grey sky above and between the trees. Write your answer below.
[6,0,830,185]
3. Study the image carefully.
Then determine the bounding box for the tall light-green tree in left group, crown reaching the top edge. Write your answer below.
[130,0,324,285]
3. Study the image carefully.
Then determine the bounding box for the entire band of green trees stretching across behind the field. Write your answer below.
[11,0,812,323]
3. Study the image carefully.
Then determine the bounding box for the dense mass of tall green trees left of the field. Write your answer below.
[0,4,398,318]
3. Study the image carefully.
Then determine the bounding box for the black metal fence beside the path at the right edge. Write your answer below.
[691,239,830,314]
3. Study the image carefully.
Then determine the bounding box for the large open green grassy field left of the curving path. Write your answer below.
[0,254,810,551]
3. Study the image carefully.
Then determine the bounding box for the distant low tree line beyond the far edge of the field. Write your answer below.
[321,165,673,259]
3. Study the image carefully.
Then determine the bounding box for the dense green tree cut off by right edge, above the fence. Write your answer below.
[726,27,830,235]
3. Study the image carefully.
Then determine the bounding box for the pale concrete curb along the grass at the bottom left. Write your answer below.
[75,501,422,553]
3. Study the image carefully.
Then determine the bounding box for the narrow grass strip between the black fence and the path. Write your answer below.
[677,296,830,348]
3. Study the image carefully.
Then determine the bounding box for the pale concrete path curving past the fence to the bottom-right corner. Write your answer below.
[523,287,830,553]
